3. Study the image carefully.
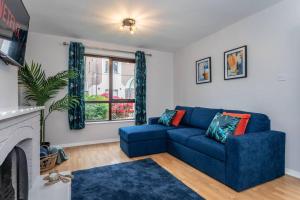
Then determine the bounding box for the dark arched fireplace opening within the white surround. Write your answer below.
[0,147,28,200]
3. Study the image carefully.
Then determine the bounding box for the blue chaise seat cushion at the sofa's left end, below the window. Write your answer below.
[119,124,174,142]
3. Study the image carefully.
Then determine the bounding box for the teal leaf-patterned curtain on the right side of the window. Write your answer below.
[135,51,147,125]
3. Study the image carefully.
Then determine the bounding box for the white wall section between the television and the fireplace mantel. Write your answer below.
[0,60,18,108]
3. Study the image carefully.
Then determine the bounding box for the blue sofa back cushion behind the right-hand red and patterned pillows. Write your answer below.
[224,110,271,133]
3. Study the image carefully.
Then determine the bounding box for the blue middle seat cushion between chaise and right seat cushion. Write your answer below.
[167,128,205,145]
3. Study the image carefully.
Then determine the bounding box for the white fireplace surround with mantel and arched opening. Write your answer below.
[0,107,43,200]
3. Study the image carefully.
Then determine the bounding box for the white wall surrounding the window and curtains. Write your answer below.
[26,33,173,144]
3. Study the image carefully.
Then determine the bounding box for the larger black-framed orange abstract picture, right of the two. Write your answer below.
[224,45,248,80]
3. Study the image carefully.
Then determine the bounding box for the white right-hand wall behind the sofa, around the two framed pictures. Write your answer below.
[174,0,300,172]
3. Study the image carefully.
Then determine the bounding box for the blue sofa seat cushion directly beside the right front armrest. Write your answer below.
[186,135,226,161]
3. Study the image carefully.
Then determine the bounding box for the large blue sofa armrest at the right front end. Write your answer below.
[225,131,285,191]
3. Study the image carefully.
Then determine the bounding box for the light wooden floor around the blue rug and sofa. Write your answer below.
[49,143,300,200]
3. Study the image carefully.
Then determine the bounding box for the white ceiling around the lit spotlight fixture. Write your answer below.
[23,0,280,51]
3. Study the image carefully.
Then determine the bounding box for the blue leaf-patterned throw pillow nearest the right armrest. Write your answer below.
[206,113,240,143]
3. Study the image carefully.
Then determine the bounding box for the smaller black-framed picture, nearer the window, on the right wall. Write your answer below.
[195,57,212,84]
